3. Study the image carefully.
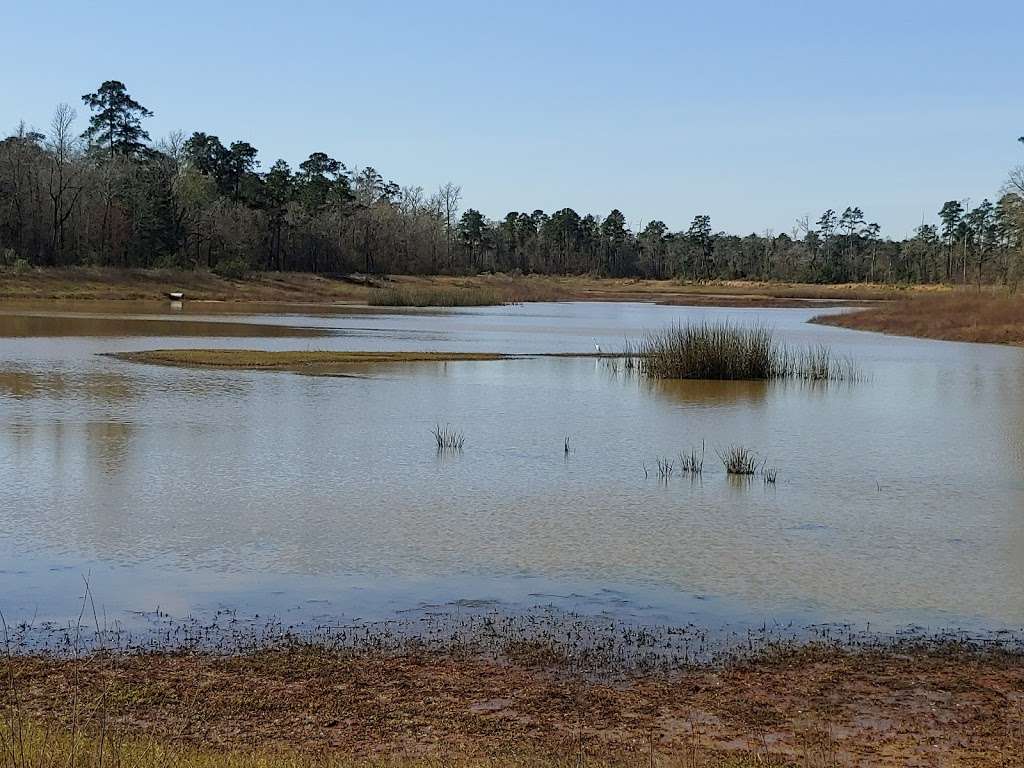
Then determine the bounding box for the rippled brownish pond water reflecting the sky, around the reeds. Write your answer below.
[0,303,1024,638]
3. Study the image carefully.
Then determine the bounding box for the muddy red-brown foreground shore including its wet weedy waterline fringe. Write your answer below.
[8,598,1024,767]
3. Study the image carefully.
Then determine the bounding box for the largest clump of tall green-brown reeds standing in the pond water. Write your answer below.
[624,323,859,381]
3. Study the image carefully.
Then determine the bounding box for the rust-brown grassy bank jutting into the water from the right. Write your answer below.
[812,289,1024,344]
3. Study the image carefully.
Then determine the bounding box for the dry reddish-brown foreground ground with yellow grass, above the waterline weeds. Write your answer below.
[6,647,1024,768]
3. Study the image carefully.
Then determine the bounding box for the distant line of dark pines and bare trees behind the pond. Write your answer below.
[6,80,1024,286]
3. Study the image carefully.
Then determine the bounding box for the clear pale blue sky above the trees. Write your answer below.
[0,0,1024,237]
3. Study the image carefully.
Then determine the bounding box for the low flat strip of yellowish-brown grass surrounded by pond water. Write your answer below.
[111,349,509,371]
